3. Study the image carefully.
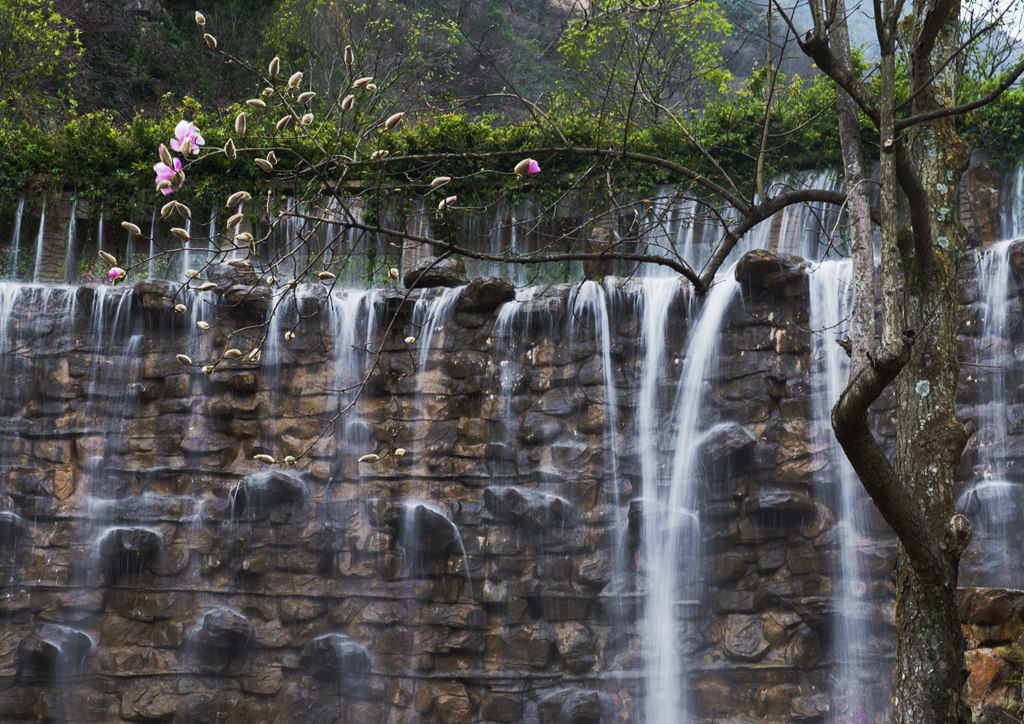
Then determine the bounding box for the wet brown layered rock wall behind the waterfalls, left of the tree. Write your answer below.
[0,250,1021,723]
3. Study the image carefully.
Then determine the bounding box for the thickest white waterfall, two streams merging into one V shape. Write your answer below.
[638,272,738,724]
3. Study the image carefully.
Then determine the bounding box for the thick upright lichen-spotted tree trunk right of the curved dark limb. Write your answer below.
[895,0,970,724]
